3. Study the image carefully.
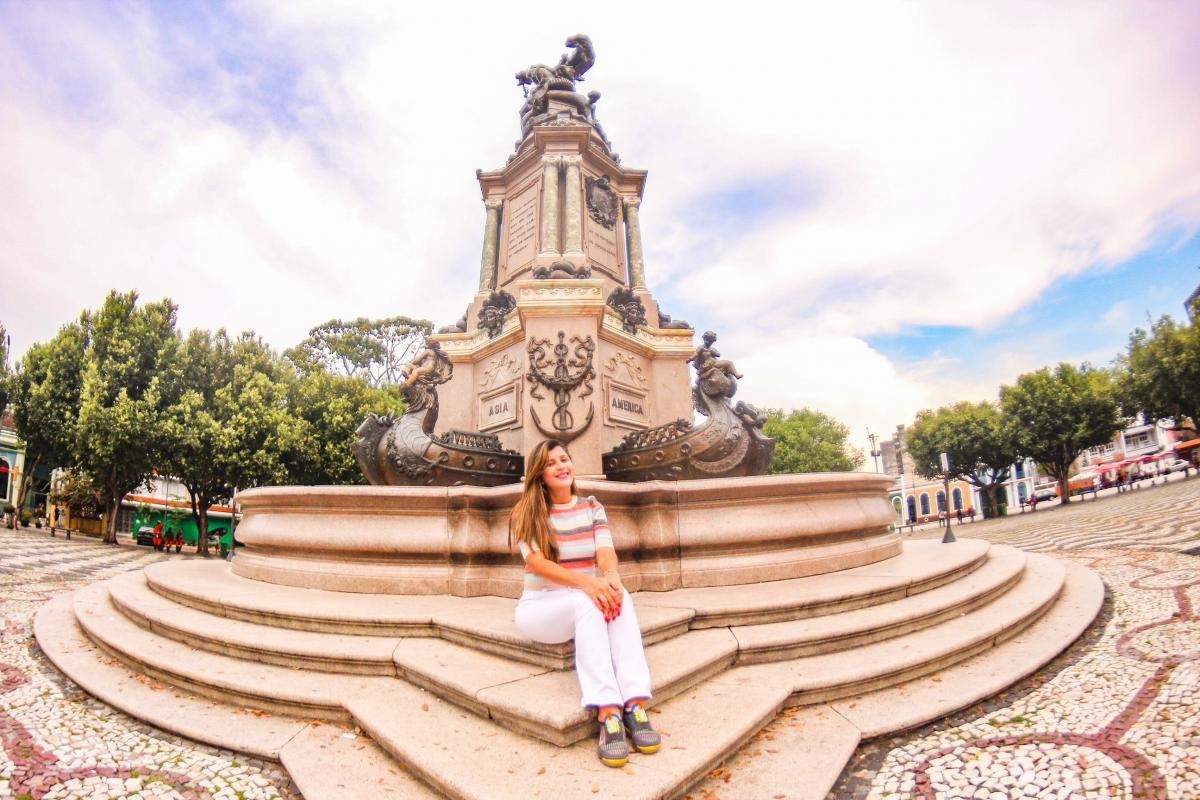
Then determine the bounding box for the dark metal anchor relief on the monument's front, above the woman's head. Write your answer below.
[526,331,596,444]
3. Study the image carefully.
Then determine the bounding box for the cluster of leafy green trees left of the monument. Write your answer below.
[0,290,422,552]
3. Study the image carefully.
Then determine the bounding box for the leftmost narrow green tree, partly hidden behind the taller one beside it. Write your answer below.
[10,323,88,527]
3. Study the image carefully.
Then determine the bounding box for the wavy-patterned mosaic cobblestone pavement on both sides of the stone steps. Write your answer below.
[0,477,1200,800]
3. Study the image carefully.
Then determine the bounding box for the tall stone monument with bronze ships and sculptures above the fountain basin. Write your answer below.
[355,35,774,486]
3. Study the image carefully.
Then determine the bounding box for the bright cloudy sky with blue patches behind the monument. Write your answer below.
[0,0,1200,462]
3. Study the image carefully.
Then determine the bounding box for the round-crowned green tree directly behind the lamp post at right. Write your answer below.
[906,401,1020,516]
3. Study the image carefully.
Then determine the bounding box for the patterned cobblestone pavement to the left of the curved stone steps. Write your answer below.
[0,528,300,800]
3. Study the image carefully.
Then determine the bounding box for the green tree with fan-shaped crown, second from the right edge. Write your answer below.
[1000,362,1121,503]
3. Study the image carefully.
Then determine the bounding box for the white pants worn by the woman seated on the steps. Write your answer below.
[516,588,650,706]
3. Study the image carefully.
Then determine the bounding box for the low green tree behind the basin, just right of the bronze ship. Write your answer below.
[762,408,863,475]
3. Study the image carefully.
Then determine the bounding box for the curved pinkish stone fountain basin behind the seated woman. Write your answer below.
[233,473,901,597]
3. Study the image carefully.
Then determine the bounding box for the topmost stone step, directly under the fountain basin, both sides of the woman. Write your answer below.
[145,540,990,669]
